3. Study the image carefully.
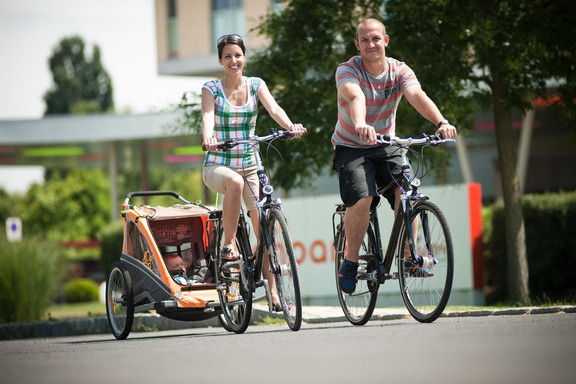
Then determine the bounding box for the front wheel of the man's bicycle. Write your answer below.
[398,200,454,323]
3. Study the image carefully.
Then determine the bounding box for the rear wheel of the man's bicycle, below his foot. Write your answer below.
[334,223,380,325]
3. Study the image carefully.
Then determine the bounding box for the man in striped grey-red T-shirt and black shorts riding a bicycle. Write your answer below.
[332,19,457,293]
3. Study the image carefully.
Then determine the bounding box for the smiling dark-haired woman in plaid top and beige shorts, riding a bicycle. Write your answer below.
[202,34,306,310]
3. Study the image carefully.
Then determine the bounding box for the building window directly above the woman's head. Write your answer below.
[212,0,246,52]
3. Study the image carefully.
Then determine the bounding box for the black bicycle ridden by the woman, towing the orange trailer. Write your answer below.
[208,129,302,333]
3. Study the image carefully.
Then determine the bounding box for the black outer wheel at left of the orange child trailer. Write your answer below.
[106,262,134,340]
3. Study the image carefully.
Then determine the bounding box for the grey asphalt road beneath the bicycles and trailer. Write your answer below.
[0,313,576,384]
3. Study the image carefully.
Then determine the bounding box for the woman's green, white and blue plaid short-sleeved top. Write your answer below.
[203,77,264,168]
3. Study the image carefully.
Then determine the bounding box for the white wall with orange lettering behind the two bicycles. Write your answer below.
[283,184,479,305]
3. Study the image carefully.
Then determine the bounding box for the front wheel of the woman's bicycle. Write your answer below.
[268,208,302,331]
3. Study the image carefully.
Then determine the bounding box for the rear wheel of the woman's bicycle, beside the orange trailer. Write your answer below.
[217,228,253,334]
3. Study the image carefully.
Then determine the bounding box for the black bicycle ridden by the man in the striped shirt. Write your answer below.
[332,135,454,325]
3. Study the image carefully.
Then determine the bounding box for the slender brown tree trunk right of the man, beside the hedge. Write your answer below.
[492,80,530,304]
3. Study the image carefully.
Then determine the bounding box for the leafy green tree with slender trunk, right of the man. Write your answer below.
[385,0,576,304]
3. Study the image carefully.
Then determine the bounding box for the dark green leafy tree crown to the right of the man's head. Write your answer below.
[384,0,576,122]
